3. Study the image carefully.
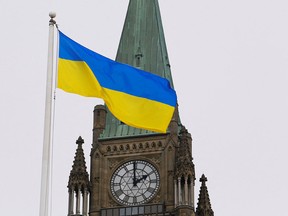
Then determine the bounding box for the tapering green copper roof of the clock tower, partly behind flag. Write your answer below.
[100,0,173,138]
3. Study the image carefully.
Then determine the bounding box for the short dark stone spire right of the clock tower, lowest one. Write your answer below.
[196,174,214,216]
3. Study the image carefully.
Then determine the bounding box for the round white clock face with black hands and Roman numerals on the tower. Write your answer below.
[111,160,160,205]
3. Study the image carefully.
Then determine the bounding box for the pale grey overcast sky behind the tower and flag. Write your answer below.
[0,0,288,216]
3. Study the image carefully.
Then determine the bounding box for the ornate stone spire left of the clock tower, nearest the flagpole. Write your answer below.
[67,136,90,216]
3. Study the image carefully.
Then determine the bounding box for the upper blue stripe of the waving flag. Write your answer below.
[59,32,177,106]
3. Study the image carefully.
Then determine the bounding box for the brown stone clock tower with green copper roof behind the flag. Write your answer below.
[68,0,214,216]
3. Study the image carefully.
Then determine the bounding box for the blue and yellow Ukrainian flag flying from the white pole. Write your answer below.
[58,31,177,133]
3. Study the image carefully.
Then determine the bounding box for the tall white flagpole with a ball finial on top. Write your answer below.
[39,12,56,216]
